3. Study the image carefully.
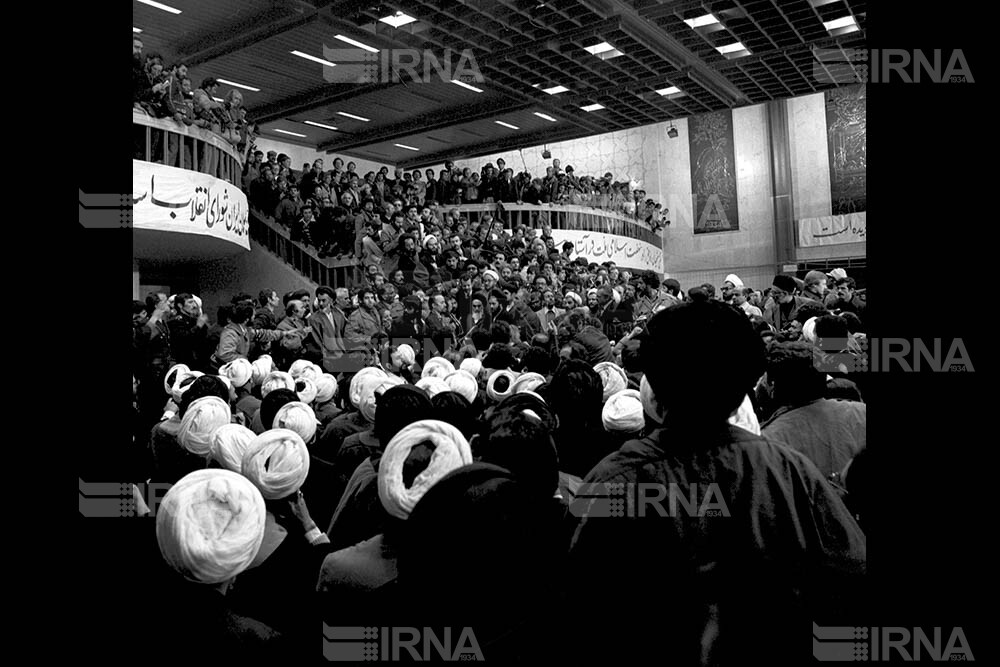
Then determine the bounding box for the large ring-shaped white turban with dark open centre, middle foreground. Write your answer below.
[378,419,472,519]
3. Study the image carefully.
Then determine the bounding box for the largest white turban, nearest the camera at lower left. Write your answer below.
[156,468,267,584]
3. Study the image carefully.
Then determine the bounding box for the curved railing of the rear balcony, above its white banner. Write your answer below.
[441,204,663,247]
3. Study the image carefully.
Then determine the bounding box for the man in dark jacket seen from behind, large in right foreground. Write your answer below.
[569,302,866,664]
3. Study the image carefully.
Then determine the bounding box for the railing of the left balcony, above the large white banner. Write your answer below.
[132,110,243,186]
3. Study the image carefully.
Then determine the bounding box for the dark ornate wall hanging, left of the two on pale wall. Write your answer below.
[688,110,740,234]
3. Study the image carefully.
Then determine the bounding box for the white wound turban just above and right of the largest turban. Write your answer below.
[241,428,309,500]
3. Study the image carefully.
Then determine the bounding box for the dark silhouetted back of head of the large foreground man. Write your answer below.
[639,302,764,424]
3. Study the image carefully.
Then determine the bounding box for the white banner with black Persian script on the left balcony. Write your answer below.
[132,160,250,250]
